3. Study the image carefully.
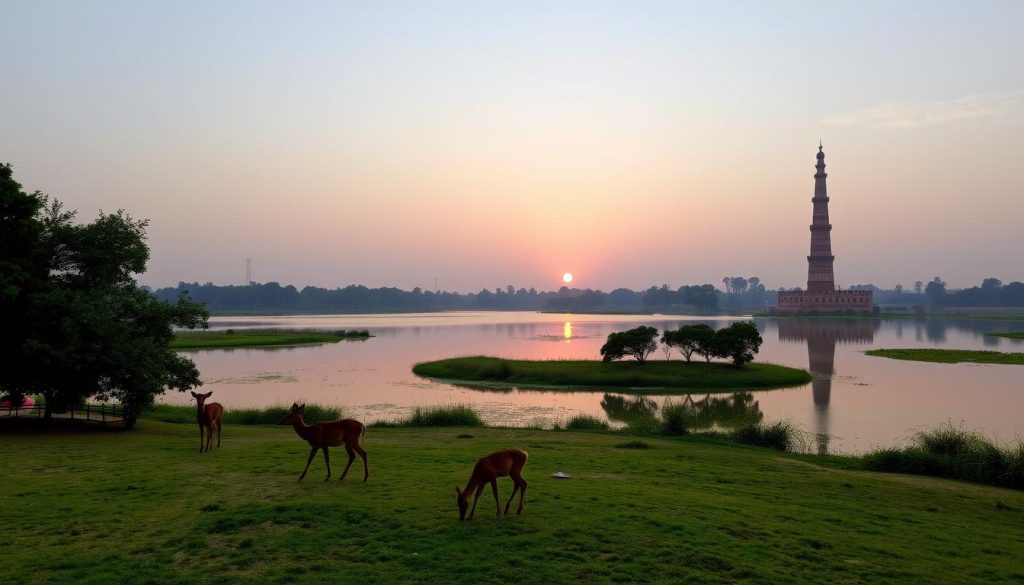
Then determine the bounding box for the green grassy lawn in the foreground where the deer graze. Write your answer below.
[0,419,1024,585]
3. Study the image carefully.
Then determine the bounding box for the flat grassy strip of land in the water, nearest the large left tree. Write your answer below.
[171,329,371,349]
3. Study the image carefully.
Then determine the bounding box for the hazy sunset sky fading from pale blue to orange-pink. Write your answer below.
[0,0,1024,292]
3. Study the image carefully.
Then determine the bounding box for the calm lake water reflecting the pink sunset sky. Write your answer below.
[163,312,1024,453]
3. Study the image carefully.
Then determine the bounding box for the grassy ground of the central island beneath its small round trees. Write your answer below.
[413,356,811,393]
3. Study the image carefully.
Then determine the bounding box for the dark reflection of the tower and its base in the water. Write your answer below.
[778,319,881,455]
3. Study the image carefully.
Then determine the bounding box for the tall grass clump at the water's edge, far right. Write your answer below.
[864,422,1024,490]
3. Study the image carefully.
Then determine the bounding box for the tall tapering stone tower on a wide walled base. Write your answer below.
[772,144,877,314]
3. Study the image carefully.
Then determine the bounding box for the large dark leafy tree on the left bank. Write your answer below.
[0,165,209,422]
